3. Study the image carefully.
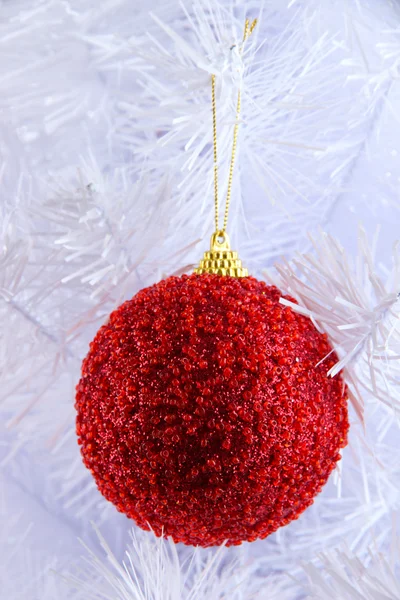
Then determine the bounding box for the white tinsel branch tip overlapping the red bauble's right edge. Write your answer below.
[268,227,400,412]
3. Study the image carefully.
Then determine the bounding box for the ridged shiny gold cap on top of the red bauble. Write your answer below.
[194,229,249,277]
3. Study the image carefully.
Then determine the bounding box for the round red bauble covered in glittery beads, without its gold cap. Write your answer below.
[76,274,349,546]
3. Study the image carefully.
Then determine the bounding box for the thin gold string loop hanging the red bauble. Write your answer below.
[211,19,257,233]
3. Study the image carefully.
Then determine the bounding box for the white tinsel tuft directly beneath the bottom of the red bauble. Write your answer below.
[64,530,293,600]
